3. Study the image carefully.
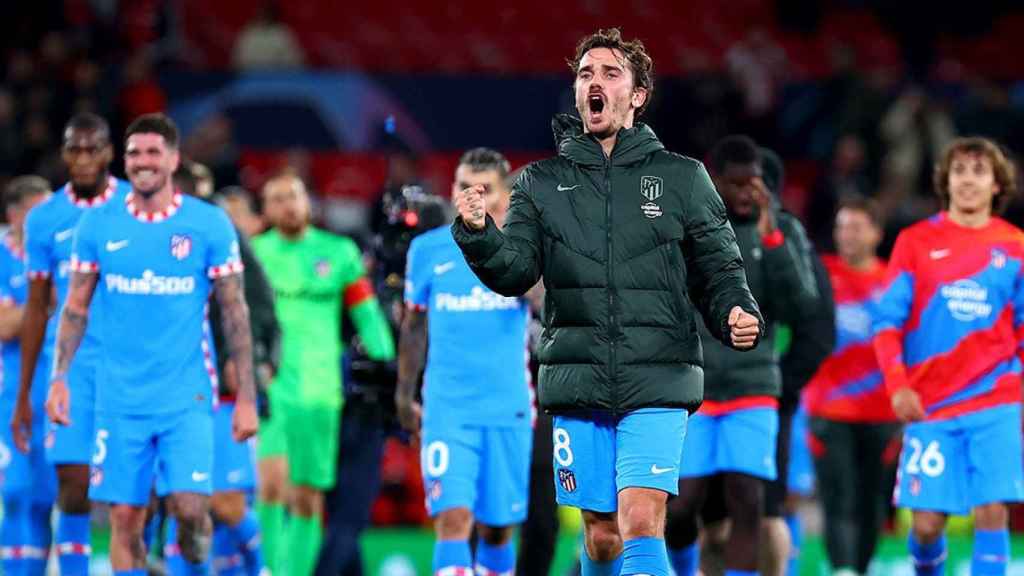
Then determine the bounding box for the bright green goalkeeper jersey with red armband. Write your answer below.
[252,227,394,406]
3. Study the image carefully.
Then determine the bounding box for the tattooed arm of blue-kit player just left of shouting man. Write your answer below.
[394,307,427,440]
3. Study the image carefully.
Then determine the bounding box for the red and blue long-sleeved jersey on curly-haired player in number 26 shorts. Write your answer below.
[873,212,1024,420]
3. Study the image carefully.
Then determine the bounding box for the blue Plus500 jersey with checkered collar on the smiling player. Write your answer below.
[72,194,242,415]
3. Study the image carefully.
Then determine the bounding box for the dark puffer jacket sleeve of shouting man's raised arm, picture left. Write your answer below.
[452,163,544,296]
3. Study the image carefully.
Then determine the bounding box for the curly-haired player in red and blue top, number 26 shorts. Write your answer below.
[871,137,1024,575]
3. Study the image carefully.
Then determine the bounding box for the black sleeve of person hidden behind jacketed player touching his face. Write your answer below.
[779,250,836,406]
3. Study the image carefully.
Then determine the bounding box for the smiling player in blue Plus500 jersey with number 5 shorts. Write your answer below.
[46,114,257,575]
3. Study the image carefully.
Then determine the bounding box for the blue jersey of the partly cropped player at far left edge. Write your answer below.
[0,233,50,410]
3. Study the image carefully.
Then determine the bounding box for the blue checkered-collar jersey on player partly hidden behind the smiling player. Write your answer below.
[25,176,131,364]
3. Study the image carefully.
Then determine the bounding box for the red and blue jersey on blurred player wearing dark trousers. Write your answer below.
[803,254,895,422]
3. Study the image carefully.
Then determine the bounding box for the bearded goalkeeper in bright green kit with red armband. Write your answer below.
[252,174,394,576]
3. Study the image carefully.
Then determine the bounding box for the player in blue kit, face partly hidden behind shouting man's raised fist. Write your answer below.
[395,149,532,576]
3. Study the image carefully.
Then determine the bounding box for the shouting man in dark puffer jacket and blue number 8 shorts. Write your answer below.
[453,30,763,576]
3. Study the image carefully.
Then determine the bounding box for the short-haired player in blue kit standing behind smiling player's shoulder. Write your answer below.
[11,114,129,574]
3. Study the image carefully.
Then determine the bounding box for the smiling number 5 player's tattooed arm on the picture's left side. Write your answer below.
[46,271,98,425]
